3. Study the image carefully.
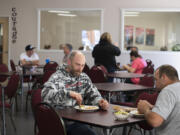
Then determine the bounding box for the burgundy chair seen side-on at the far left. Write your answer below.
[0,73,20,131]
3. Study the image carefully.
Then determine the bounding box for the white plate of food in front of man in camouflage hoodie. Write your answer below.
[74,105,99,112]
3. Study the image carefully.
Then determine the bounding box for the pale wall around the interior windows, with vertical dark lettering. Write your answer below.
[0,0,180,75]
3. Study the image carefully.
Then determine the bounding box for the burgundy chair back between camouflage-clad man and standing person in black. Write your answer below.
[89,65,107,83]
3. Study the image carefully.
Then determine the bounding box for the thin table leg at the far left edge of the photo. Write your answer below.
[1,88,6,135]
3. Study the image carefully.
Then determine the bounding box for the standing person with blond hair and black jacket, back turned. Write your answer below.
[92,32,121,82]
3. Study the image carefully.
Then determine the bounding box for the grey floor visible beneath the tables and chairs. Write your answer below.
[1,88,153,135]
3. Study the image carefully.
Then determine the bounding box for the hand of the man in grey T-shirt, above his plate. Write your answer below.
[137,100,153,114]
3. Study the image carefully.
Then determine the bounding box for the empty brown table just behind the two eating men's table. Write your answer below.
[93,82,154,103]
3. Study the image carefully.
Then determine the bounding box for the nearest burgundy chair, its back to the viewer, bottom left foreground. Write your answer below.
[34,103,66,135]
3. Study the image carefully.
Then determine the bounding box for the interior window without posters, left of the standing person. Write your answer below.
[38,9,102,50]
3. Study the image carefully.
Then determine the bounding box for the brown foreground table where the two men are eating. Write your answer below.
[56,104,145,135]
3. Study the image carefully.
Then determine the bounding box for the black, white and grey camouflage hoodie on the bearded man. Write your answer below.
[41,64,102,106]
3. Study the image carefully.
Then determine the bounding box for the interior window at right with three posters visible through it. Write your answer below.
[121,10,180,51]
